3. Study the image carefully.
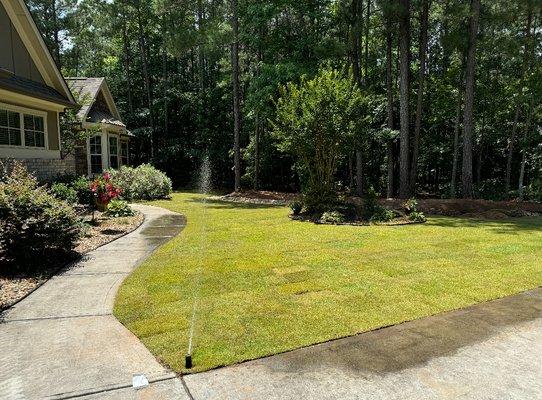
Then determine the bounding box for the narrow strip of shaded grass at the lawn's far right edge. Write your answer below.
[425,216,542,235]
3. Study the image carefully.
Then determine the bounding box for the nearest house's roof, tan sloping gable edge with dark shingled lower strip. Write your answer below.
[0,0,77,107]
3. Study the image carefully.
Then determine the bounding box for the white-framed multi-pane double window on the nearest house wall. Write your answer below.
[0,104,47,149]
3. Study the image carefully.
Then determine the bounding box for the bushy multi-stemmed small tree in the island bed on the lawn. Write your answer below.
[273,69,361,211]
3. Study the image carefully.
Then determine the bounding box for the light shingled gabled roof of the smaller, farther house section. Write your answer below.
[66,77,126,127]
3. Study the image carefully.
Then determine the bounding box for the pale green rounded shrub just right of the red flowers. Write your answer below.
[110,164,172,200]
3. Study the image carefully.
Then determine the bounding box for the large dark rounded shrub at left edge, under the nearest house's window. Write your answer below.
[0,163,80,267]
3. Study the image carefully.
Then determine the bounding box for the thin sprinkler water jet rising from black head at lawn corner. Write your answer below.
[184,156,211,369]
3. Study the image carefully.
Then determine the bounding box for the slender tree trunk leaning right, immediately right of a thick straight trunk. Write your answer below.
[410,0,429,194]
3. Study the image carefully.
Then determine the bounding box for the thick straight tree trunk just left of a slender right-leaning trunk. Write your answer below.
[399,0,410,199]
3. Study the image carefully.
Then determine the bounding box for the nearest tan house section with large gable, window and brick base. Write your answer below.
[0,0,77,179]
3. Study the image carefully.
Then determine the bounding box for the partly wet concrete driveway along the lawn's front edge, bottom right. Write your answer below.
[184,289,542,400]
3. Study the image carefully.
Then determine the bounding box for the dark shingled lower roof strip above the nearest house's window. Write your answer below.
[0,70,74,107]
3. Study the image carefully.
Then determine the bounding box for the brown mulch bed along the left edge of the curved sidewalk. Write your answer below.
[0,212,145,311]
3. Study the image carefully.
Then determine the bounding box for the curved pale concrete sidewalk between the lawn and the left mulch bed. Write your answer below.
[0,205,189,400]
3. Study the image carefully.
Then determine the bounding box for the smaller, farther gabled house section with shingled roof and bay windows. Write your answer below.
[66,78,131,175]
